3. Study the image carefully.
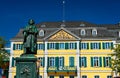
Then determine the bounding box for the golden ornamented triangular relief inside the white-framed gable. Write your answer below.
[49,30,76,40]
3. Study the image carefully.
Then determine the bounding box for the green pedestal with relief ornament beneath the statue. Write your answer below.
[15,54,39,78]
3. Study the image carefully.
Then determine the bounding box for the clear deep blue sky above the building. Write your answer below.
[0,0,120,44]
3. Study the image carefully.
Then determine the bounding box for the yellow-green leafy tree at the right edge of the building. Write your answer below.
[111,44,120,76]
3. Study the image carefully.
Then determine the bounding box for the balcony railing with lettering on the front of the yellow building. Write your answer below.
[47,66,77,72]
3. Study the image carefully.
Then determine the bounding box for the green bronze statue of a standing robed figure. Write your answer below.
[23,19,38,54]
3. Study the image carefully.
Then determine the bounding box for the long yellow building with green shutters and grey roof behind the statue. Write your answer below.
[9,21,120,78]
